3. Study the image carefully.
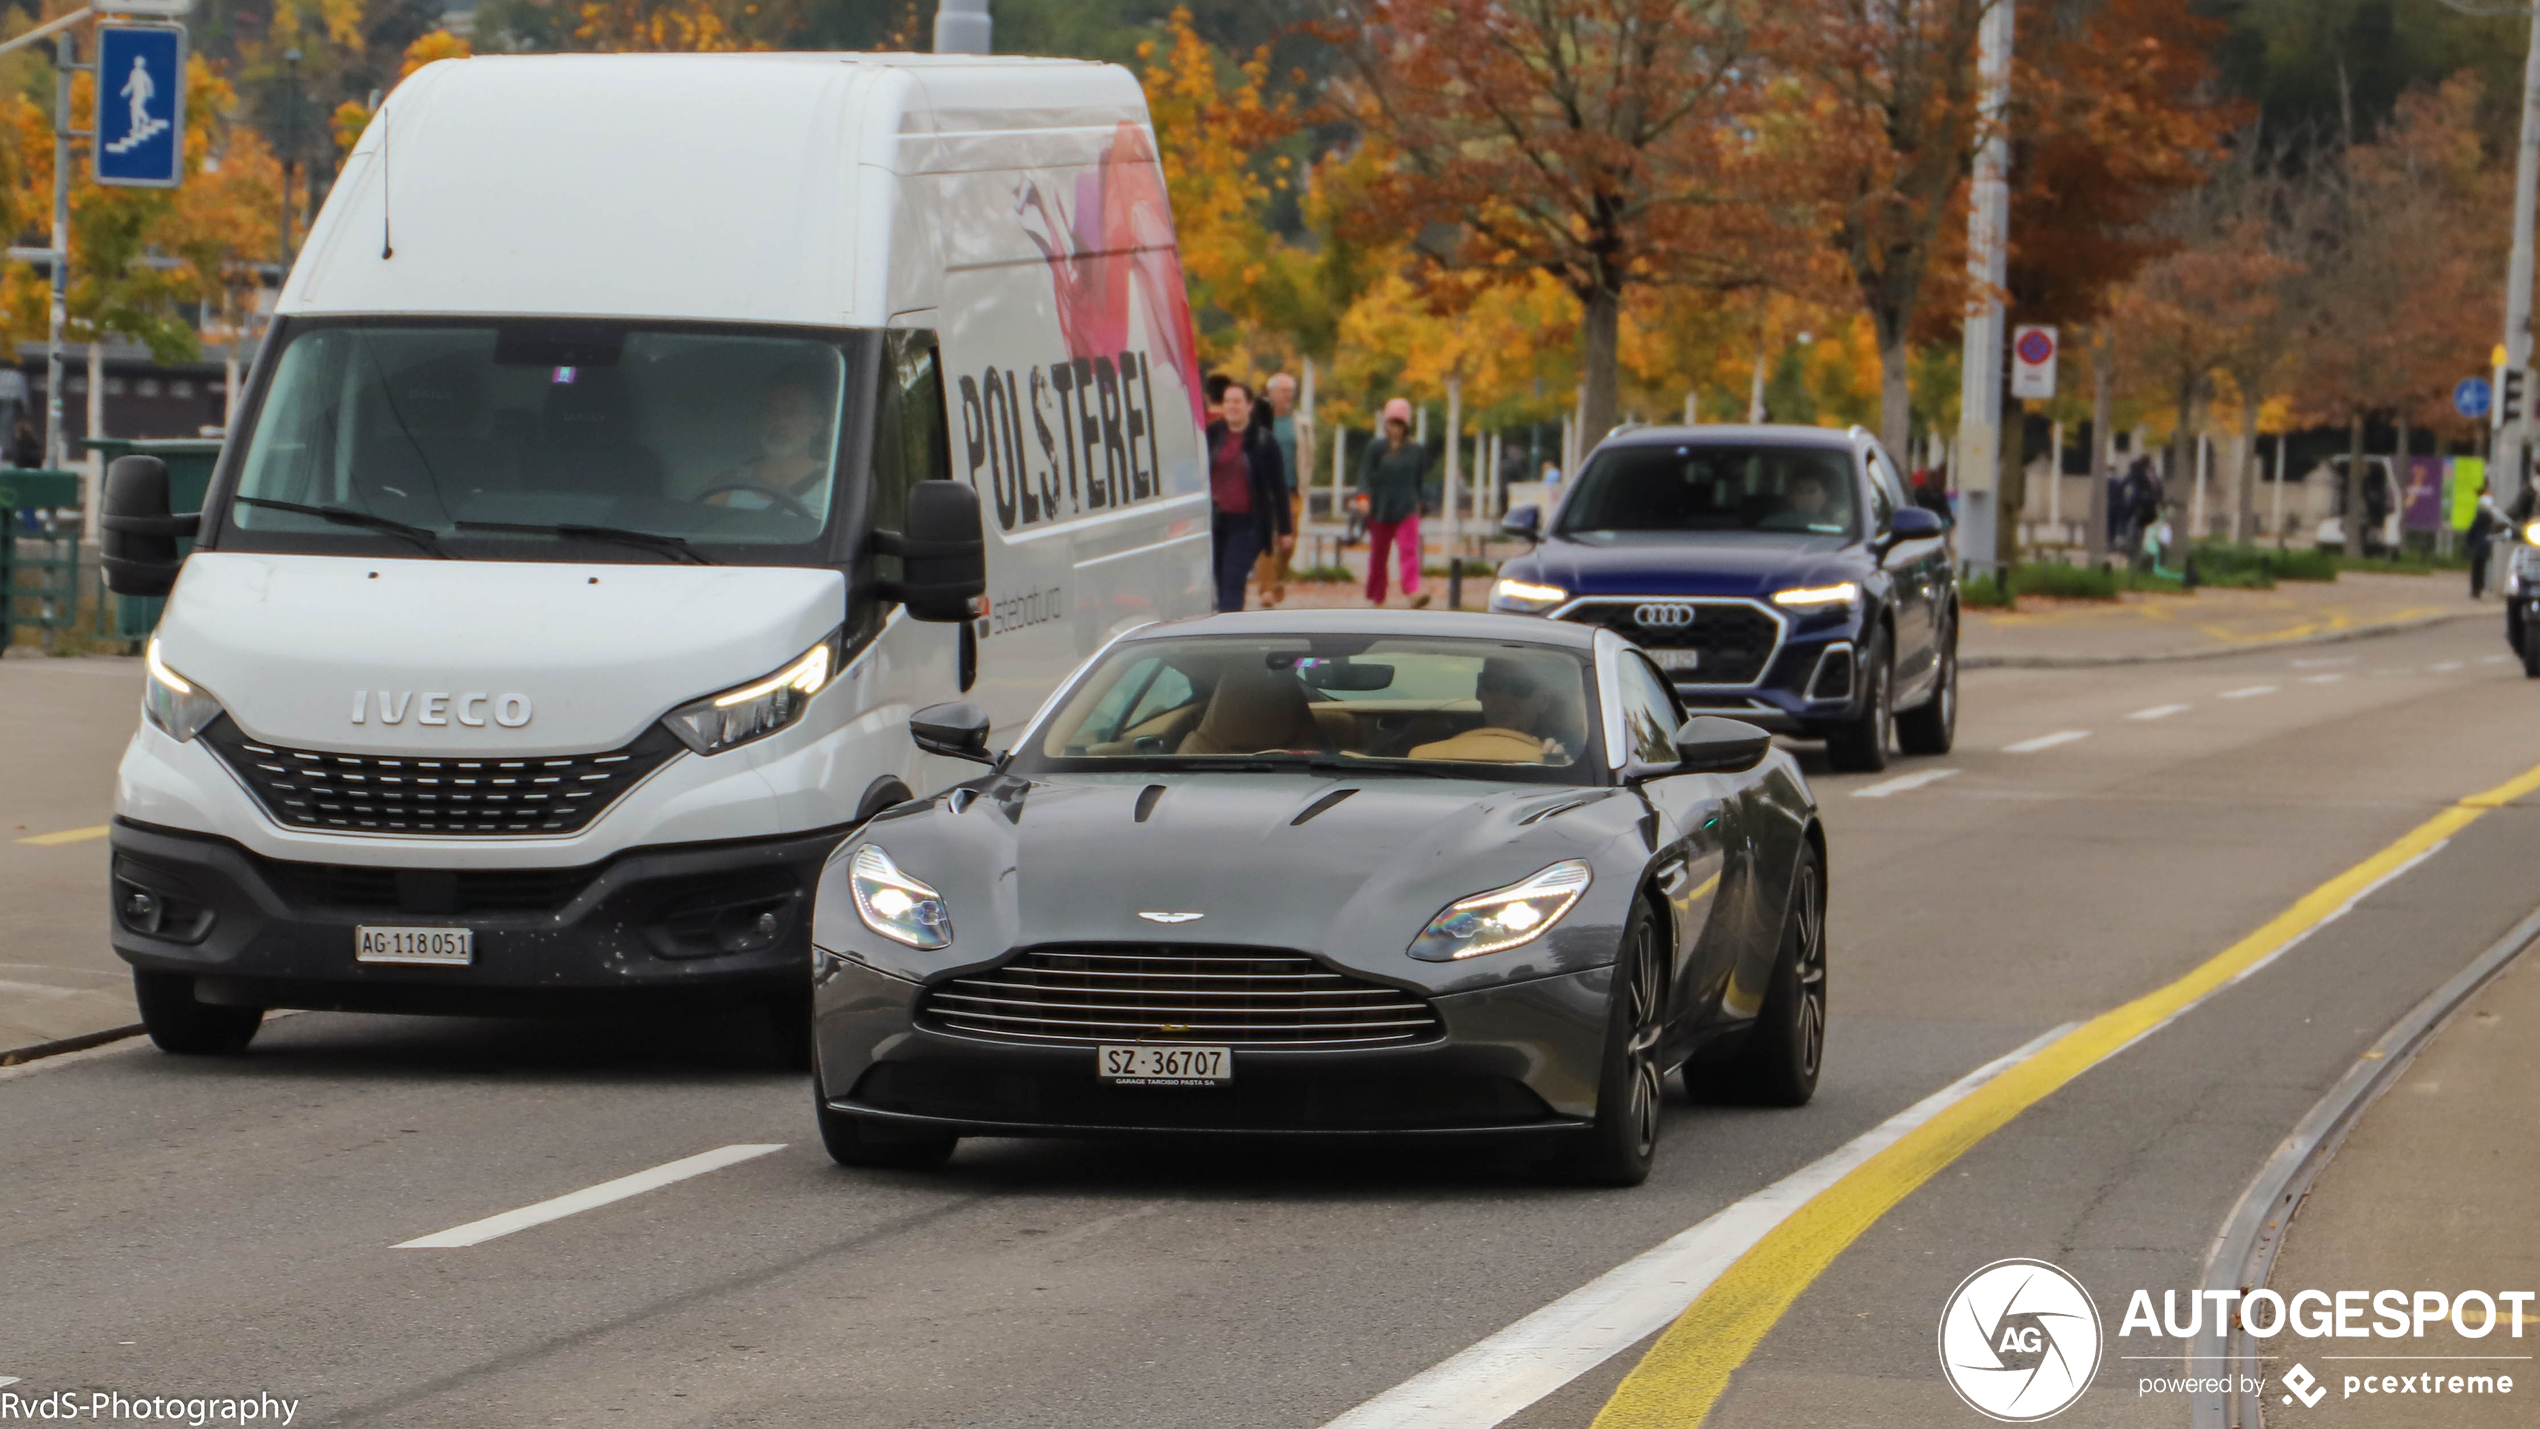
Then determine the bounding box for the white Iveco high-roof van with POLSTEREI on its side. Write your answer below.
[104,53,1209,1051]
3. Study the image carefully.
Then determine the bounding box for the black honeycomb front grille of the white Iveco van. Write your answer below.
[203,716,683,838]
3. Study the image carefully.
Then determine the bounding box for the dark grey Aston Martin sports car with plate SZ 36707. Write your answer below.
[813,609,1826,1185]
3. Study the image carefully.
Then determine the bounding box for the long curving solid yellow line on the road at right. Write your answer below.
[1595,767,2540,1429]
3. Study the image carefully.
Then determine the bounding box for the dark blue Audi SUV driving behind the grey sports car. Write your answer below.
[1491,426,1958,769]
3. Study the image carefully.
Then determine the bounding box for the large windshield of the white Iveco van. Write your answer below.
[224,320,851,561]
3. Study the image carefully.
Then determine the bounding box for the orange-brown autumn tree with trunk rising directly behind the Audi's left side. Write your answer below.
[1326,0,1803,434]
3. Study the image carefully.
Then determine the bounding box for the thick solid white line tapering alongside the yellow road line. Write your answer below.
[1323,1023,2080,1429]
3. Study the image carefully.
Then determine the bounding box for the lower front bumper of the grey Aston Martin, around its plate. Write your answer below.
[813,954,1613,1137]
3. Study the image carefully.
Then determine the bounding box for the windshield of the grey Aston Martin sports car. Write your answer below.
[1026,635,1600,784]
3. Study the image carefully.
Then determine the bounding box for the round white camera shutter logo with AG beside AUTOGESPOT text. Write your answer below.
[1941,1259,2101,1424]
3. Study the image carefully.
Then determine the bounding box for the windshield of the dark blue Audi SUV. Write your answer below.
[1557,444,1857,536]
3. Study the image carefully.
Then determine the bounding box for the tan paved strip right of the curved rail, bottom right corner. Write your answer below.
[2261,952,2540,1429]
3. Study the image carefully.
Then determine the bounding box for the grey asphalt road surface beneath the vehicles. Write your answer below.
[0,622,2540,1429]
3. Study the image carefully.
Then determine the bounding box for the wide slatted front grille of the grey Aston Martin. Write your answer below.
[917,944,1443,1046]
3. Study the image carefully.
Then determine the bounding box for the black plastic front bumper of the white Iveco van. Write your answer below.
[107,820,848,1013]
